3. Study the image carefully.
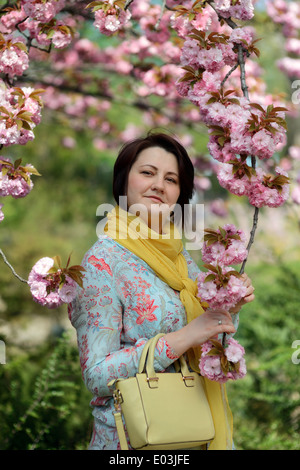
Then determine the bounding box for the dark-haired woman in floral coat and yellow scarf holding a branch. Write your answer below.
[70,130,254,450]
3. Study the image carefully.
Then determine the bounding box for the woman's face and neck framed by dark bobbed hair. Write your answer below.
[127,147,180,232]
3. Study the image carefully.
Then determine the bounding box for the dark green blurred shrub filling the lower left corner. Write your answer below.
[0,335,92,450]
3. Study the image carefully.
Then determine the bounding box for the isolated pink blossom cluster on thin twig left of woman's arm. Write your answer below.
[28,257,76,309]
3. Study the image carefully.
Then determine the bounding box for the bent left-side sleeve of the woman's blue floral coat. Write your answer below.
[69,248,178,397]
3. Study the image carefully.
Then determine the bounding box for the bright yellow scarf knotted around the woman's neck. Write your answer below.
[104,206,232,450]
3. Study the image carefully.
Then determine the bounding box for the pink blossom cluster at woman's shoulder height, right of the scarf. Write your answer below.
[202,224,248,266]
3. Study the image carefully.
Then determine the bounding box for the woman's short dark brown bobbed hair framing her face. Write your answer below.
[113,132,194,214]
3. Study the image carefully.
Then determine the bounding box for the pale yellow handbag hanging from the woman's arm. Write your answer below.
[109,334,215,450]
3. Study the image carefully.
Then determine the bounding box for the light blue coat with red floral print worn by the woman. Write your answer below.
[69,235,239,450]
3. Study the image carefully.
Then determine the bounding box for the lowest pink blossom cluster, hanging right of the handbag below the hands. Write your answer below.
[199,338,247,383]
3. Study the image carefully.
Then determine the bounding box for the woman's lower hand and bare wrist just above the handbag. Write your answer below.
[165,309,235,356]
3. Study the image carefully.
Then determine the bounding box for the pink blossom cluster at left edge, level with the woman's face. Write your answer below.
[0,157,38,199]
